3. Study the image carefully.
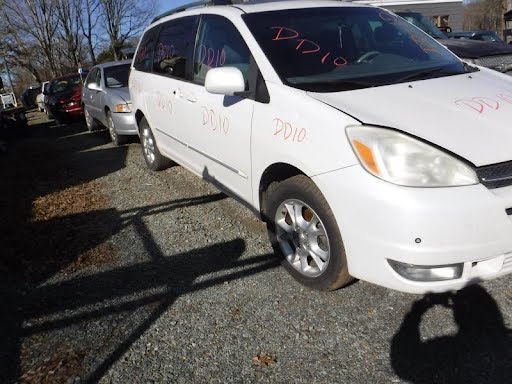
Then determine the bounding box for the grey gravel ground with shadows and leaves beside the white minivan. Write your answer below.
[0,113,512,384]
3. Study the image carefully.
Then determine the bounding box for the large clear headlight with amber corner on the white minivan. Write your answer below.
[347,126,479,187]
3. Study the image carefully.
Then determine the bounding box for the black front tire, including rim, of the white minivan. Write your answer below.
[264,175,354,291]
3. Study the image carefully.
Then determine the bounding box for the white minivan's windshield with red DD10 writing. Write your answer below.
[243,7,465,92]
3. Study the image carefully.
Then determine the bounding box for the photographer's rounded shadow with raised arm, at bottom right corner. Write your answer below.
[391,285,512,384]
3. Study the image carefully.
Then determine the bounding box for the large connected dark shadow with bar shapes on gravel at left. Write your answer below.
[0,115,279,383]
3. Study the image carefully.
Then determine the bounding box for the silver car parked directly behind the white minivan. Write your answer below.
[82,60,137,145]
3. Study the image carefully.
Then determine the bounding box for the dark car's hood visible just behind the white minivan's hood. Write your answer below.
[437,39,512,59]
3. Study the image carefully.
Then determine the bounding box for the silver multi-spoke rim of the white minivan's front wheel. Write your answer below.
[274,199,331,277]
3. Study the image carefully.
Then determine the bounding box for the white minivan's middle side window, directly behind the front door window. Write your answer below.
[153,16,197,79]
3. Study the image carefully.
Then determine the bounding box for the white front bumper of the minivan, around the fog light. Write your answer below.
[313,165,512,294]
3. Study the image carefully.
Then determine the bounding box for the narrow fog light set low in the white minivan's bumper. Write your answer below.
[388,259,464,281]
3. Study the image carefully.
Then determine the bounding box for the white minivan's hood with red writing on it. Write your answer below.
[308,71,512,166]
